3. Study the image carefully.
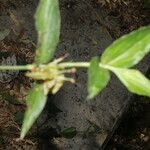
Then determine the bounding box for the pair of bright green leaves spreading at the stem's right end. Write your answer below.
[98,26,150,96]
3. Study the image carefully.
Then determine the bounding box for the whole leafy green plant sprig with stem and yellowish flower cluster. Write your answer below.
[0,0,150,139]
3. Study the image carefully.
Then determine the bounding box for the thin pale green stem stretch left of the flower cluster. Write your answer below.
[0,65,34,70]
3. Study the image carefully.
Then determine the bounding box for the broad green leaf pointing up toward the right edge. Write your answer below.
[101,26,150,68]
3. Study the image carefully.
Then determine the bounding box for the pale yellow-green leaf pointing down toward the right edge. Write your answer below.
[112,69,150,96]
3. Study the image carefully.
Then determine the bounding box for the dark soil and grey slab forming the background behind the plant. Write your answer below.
[0,0,150,150]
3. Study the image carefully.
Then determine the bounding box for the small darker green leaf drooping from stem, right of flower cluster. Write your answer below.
[88,57,110,99]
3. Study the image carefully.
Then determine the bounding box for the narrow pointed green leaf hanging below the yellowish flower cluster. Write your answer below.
[20,84,47,139]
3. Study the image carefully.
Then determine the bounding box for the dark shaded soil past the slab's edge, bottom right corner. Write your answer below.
[106,97,150,150]
